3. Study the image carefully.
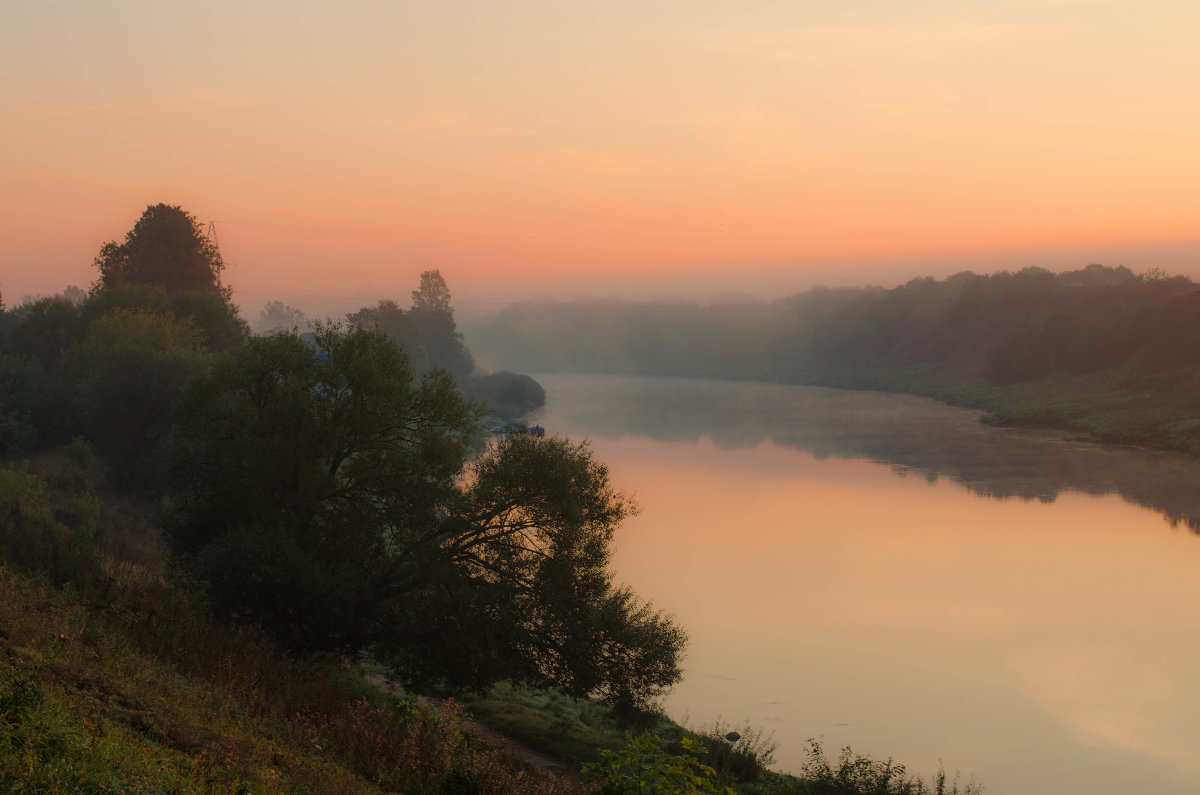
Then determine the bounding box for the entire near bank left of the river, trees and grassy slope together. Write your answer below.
[0,205,977,794]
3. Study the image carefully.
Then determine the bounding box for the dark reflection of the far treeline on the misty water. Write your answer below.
[539,376,1200,532]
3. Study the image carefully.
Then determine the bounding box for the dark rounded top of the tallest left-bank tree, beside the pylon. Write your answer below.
[95,204,224,293]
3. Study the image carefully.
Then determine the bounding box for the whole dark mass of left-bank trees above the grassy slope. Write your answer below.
[0,204,685,716]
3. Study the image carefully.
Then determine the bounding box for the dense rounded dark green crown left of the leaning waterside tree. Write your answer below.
[170,325,475,651]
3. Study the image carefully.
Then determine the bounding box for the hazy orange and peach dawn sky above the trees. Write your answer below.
[0,0,1200,317]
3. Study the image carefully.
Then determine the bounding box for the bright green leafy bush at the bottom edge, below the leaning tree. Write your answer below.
[583,731,733,795]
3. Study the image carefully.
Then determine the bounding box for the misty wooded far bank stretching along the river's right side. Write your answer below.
[472,264,1200,452]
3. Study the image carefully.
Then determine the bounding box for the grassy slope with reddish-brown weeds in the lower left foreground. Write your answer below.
[0,458,580,793]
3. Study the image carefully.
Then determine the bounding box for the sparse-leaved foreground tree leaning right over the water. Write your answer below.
[383,435,686,718]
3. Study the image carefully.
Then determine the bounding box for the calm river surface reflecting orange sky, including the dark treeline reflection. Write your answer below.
[528,376,1200,795]
